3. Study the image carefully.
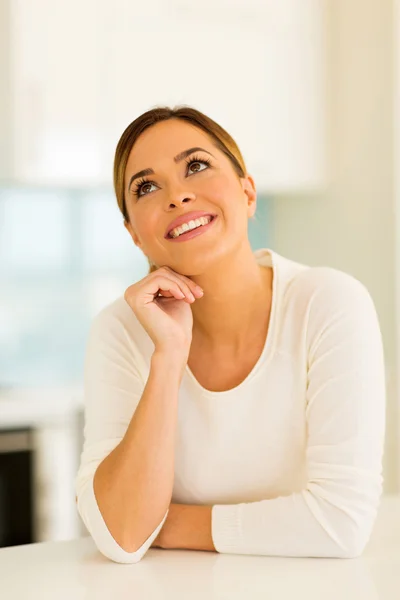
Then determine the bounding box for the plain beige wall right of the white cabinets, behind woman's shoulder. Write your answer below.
[271,0,400,492]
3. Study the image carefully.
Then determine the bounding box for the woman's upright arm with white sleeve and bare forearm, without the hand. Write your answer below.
[76,314,186,562]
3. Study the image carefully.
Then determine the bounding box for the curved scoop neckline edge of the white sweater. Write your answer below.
[185,248,279,398]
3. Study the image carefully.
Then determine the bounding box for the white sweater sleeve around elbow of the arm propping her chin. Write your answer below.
[75,309,168,563]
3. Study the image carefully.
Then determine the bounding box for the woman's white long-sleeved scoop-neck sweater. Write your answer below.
[76,248,385,563]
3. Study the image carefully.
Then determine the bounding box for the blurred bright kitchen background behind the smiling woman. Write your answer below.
[0,0,400,546]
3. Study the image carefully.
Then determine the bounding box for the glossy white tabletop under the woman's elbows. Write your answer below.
[0,496,400,600]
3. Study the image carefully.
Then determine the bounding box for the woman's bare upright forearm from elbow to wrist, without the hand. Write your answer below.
[94,352,188,552]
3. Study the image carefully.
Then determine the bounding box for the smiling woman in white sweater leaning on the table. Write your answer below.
[76,107,385,563]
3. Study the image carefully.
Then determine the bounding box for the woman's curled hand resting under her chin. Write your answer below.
[124,266,202,352]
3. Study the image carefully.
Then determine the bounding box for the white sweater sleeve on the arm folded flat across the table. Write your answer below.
[212,267,385,558]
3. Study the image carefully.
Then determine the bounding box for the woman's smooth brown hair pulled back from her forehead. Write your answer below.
[114,106,255,273]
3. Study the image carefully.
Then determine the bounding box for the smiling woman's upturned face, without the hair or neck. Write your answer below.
[124,119,256,276]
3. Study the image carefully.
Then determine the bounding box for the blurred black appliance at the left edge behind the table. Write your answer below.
[0,429,34,547]
